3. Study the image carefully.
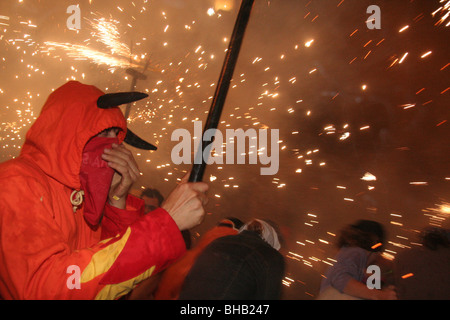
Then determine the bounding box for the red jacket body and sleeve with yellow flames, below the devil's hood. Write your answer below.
[0,177,185,299]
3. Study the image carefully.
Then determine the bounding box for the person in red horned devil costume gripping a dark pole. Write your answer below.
[0,81,208,299]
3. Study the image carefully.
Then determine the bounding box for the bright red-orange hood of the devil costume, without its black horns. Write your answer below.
[20,81,127,189]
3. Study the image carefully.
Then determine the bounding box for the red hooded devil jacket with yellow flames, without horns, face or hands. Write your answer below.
[0,81,185,299]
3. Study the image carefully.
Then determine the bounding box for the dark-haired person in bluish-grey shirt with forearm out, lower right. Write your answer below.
[318,220,396,300]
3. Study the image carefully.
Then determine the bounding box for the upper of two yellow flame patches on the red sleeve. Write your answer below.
[80,228,131,283]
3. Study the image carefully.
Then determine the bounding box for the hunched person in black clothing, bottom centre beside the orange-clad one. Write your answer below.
[180,219,285,300]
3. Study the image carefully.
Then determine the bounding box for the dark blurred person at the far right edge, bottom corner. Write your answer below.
[394,228,450,300]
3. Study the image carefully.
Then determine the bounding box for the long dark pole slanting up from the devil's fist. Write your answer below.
[189,0,254,182]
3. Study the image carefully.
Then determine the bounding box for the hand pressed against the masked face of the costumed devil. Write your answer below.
[102,143,140,209]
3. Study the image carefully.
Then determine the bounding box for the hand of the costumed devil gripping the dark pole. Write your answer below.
[161,172,209,231]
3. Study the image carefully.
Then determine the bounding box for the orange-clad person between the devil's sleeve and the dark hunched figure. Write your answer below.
[155,218,244,300]
